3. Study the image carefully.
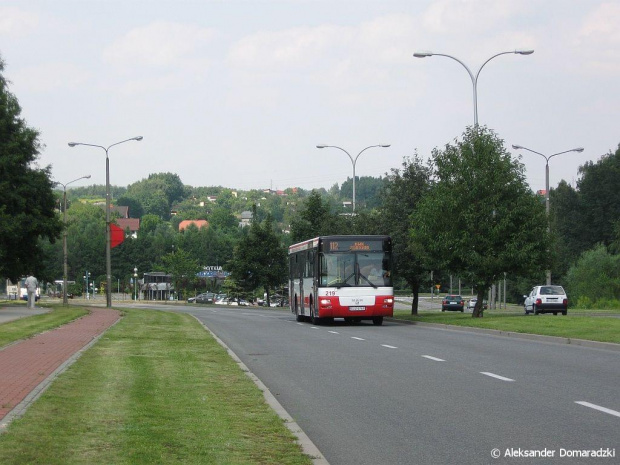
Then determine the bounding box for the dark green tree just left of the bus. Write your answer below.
[228,217,288,304]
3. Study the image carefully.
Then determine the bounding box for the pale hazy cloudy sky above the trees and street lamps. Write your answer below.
[0,0,620,190]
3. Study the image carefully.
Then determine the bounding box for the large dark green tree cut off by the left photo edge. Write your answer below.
[0,54,62,281]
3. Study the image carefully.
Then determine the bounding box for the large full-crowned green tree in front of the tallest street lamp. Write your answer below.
[411,127,549,317]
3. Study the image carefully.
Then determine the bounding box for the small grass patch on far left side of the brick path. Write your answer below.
[0,307,88,347]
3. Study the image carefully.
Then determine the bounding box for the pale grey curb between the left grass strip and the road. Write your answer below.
[190,314,329,465]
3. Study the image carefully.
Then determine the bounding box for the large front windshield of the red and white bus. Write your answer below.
[319,252,392,287]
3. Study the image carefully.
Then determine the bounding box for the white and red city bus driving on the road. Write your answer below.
[289,235,394,325]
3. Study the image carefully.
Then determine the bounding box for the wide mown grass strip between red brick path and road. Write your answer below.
[0,310,311,465]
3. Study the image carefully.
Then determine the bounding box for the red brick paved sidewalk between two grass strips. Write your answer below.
[0,308,120,424]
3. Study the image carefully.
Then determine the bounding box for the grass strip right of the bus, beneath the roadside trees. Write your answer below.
[394,308,620,344]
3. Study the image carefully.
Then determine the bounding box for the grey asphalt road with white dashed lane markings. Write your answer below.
[156,306,620,465]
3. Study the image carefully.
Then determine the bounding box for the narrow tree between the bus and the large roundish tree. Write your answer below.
[380,154,432,315]
